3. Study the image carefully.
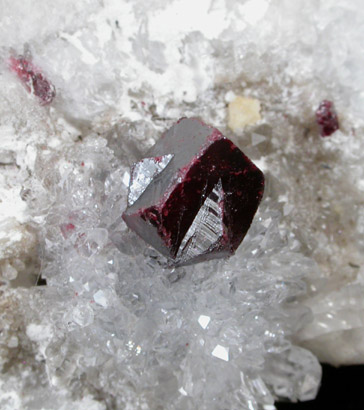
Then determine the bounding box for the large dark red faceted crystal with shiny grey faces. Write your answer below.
[123,118,264,265]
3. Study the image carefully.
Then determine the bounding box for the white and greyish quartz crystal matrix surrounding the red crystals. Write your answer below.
[0,0,364,409]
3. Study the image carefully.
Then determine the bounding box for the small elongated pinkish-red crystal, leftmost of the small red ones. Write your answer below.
[9,56,56,105]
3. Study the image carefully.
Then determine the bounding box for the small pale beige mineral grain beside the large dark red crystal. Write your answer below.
[228,96,261,132]
